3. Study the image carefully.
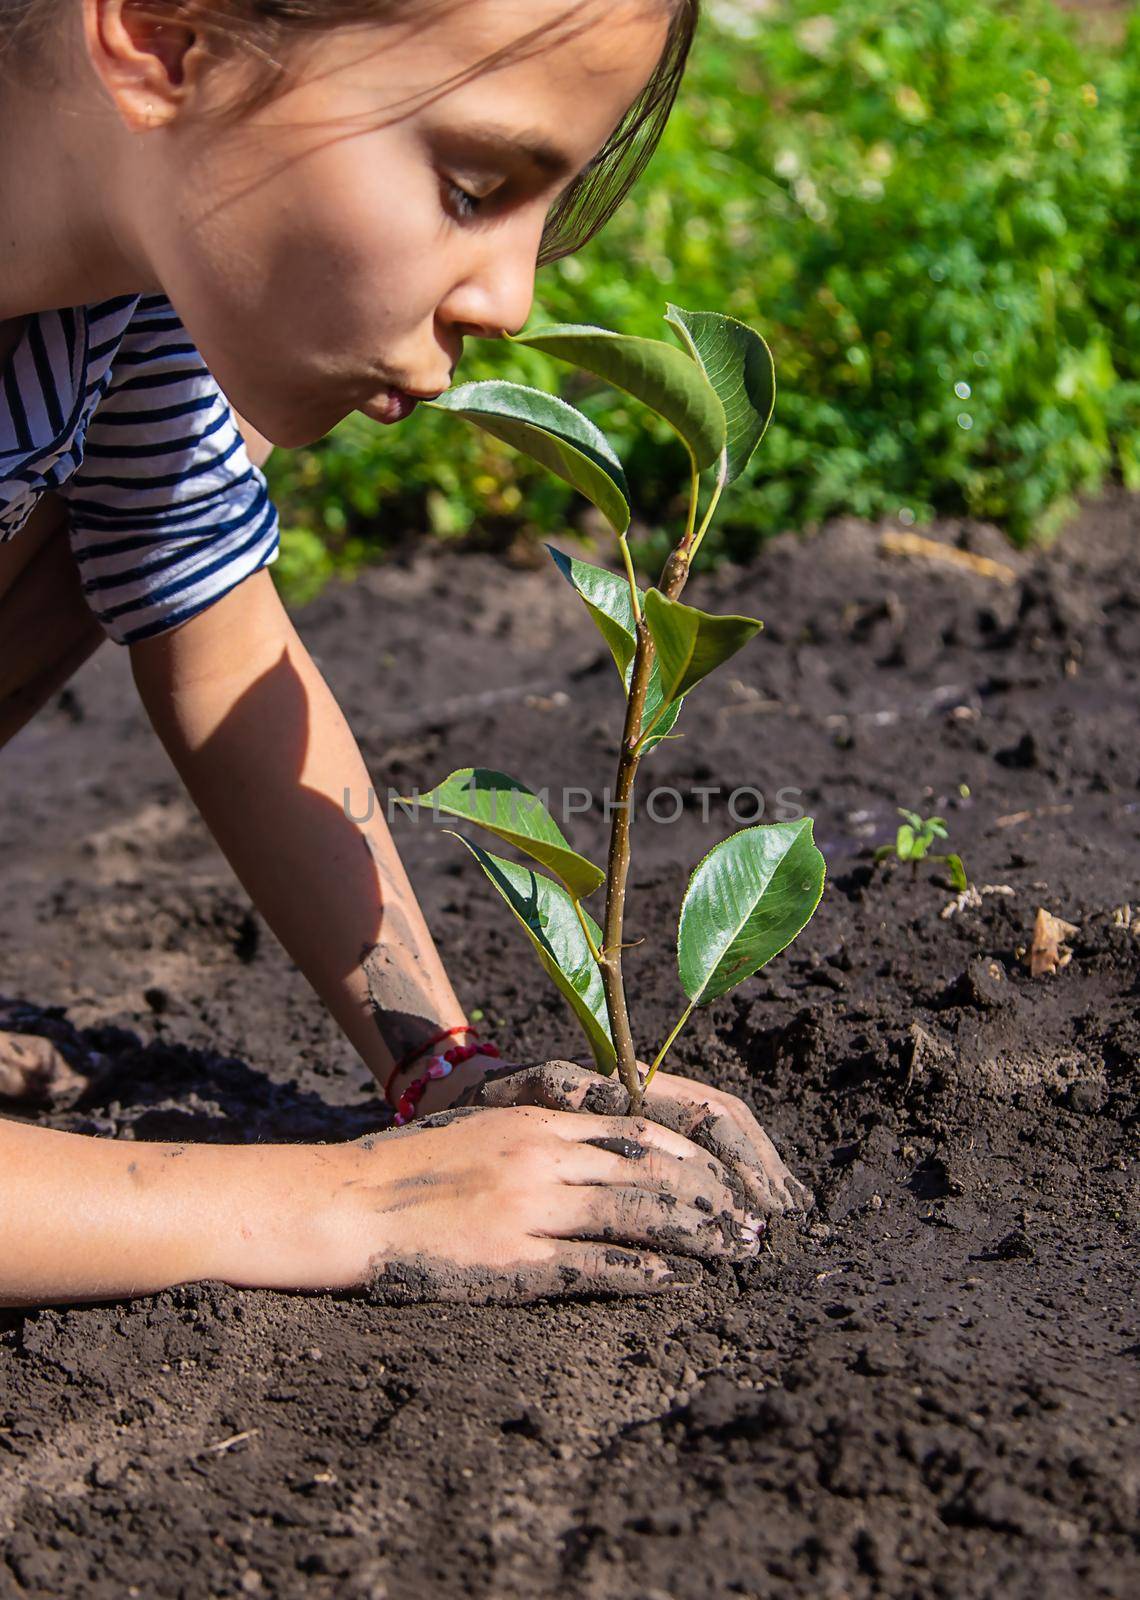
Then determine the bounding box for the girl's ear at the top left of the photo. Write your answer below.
[83,0,210,133]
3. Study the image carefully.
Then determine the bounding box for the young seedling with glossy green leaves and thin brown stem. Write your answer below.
[408,306,825,1110]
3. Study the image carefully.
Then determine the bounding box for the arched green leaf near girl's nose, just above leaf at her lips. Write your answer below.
[512,323,727,470]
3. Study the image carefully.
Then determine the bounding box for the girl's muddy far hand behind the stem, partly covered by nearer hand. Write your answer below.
[464,1061,812,1214]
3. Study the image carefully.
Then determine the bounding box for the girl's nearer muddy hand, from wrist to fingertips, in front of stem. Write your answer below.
[288,1107,761,1302]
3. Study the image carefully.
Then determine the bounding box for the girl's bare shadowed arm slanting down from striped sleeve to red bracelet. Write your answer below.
[131,568,480,1110]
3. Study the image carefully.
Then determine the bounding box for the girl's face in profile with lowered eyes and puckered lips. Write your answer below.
[98,0,668,446]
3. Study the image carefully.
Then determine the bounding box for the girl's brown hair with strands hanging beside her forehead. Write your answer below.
[0,0,700,266]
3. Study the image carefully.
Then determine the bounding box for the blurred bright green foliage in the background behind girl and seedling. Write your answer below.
[271,0,1140,589]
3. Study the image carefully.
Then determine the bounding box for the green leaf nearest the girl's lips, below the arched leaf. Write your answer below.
[428,379,629,534]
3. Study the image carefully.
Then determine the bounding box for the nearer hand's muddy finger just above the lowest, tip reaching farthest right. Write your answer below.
[548,1184,761,1261]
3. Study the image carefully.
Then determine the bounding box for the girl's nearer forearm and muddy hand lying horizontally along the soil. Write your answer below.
[0,1109,757,1306]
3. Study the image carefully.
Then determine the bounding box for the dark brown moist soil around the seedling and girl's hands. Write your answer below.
[0,498,1140,1600]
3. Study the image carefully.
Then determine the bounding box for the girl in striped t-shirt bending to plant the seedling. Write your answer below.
[0,0,805,1304]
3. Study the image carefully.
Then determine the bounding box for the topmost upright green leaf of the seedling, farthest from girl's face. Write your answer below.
[664,306,777,483]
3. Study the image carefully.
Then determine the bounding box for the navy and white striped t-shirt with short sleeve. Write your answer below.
[0,294,279,645]
